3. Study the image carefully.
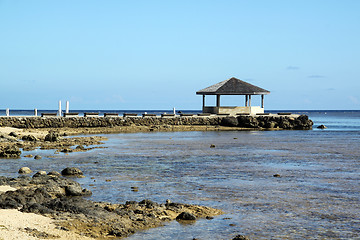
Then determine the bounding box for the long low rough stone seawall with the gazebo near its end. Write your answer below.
[0,115,313,129]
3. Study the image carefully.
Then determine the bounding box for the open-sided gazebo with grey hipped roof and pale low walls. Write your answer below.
[196,77,270,115]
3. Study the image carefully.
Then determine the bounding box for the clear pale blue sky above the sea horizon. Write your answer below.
[0,0,360,110]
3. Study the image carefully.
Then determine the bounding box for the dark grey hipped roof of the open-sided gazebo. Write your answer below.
[196,77,270,95]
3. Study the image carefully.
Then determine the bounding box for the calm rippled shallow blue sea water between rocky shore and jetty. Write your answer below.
[0,111,360,239]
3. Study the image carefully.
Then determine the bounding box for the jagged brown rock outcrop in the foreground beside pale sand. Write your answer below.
[0,168,222,239]
